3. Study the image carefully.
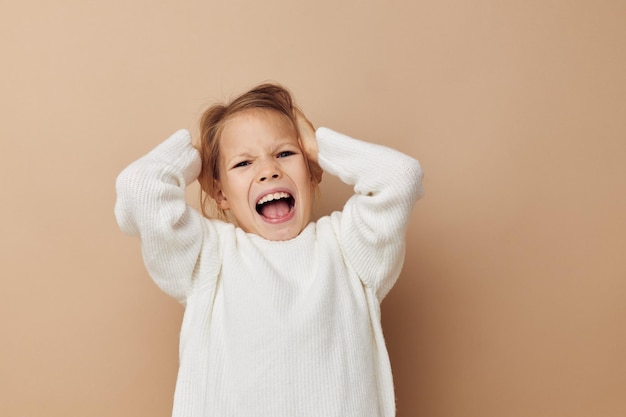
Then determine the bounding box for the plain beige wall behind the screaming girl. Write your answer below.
[0,0,626,417]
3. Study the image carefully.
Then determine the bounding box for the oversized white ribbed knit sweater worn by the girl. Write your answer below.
[115,128,422,417]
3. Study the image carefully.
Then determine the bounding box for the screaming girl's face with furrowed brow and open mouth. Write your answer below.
[214,109,314,240]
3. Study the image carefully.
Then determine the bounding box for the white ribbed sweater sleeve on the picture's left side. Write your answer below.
[115,130,203,302]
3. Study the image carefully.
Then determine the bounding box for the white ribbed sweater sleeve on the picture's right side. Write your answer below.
[316,128,423,302]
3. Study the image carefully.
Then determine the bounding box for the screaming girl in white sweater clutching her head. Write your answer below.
[115,84,422,417]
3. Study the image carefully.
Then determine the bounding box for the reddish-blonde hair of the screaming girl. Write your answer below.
[198,84,321,220]
